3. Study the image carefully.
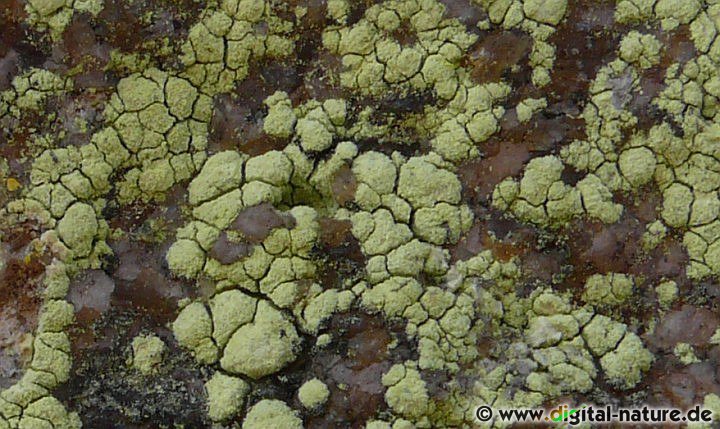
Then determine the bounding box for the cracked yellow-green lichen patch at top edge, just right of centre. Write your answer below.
[323,0,474,98]
